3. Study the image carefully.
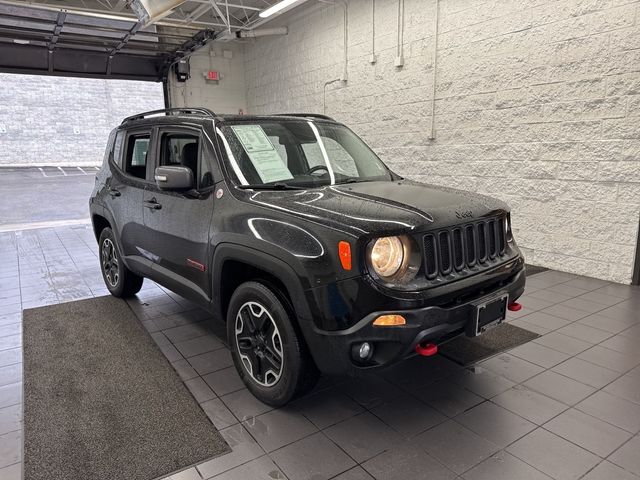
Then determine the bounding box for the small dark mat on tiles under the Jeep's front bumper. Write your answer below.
[438,323,540,366]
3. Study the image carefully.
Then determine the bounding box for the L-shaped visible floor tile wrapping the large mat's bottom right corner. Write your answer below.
[196,425,264,480]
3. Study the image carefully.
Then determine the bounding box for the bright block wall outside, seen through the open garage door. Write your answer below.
[0,73,164,166]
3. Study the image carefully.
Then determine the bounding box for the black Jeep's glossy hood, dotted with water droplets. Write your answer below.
[240,180,508,236]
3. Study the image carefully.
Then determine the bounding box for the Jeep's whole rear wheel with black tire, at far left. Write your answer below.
[98,227,144,298]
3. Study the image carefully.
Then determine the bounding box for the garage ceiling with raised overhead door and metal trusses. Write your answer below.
[0,0,284,81]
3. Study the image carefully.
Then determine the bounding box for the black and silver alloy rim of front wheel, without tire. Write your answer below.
[235,302,284,387]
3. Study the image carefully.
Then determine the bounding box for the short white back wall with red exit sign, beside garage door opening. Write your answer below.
[169,42,247,113]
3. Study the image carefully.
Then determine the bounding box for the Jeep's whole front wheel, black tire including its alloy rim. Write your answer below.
[227,282,320,407]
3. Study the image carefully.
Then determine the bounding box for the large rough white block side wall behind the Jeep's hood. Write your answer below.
[245,0,640,283]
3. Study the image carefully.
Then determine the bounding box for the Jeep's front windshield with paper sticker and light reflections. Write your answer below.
[218,120,391,187]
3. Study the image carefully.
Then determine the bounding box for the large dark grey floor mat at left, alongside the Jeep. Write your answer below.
[23,297,230,480]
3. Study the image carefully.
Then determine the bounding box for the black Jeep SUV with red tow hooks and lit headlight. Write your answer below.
[90,108,525,405]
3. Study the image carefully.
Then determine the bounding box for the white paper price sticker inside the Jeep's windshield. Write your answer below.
[231,125,293,183]
